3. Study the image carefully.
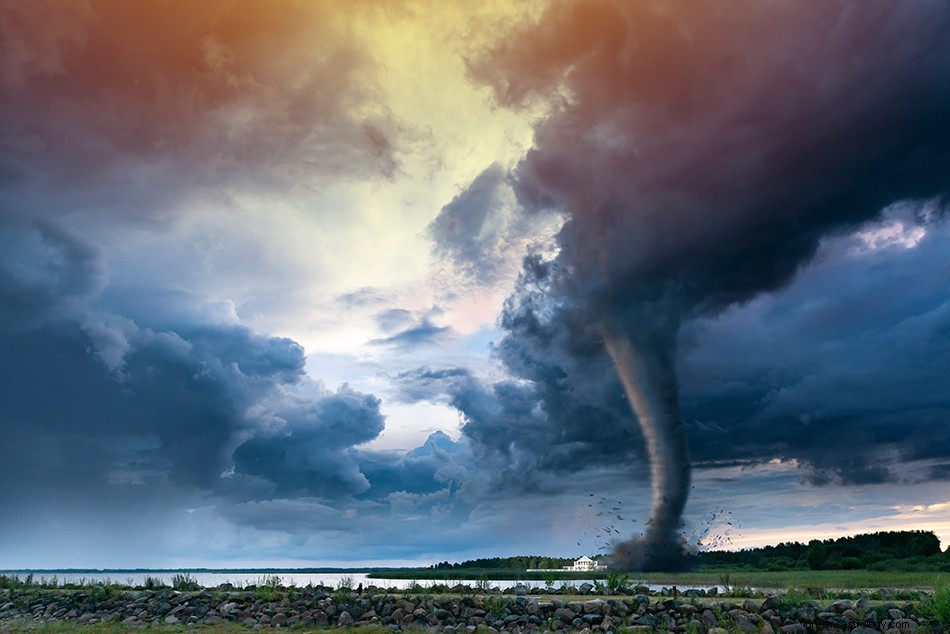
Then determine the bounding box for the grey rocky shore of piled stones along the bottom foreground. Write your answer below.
[0,584,946,634]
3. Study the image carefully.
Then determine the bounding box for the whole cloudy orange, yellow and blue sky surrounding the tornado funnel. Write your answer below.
[0,0,950,569]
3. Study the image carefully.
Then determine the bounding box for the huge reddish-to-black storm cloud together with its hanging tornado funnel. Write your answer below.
[471,1,950,567]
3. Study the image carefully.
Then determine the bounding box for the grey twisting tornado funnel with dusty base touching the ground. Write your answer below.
[600,322,690,571]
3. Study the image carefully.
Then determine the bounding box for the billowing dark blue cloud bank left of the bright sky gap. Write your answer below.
[0,220,398,512]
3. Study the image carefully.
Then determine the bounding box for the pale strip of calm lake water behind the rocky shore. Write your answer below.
[0,570,713,591]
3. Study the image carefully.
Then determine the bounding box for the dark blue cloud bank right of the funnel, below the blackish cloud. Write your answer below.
[680,207,950,484]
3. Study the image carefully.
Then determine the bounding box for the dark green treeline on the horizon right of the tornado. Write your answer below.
[699,531,950,572]
